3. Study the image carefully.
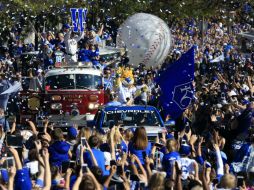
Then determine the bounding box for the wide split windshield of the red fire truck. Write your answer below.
[45,74,102,90]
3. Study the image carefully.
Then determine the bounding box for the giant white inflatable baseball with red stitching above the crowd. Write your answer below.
[116,13,171,66]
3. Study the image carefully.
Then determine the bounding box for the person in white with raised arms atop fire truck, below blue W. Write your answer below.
[64,26,84,64]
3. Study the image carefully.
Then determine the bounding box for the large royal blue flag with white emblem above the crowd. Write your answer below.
[157,47,194,119]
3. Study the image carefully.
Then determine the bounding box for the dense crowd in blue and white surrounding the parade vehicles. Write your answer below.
[0,1,254,190]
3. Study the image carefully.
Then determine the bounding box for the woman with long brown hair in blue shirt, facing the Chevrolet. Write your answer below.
[128,127,152,165]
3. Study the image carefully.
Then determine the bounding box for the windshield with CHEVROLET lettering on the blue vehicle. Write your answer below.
[103,110,161,127]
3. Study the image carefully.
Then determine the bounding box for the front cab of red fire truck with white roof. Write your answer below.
[44,63,104,125]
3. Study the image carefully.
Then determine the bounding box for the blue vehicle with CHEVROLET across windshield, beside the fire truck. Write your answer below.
[92,105,166,139]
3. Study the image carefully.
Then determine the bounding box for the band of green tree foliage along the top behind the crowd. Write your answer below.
[0,0,254,44]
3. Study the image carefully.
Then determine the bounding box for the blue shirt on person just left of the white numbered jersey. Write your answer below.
[162,152,180,178]
